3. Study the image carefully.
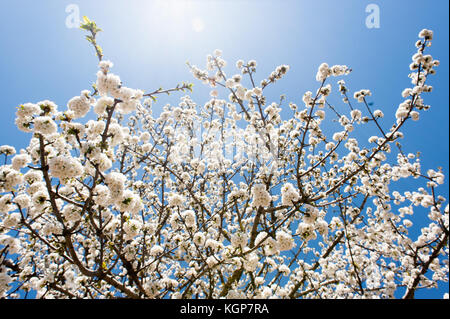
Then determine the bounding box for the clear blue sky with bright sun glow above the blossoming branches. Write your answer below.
[0,0,449,300]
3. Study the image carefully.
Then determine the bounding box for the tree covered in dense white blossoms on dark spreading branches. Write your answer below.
[0,18,449,298]
